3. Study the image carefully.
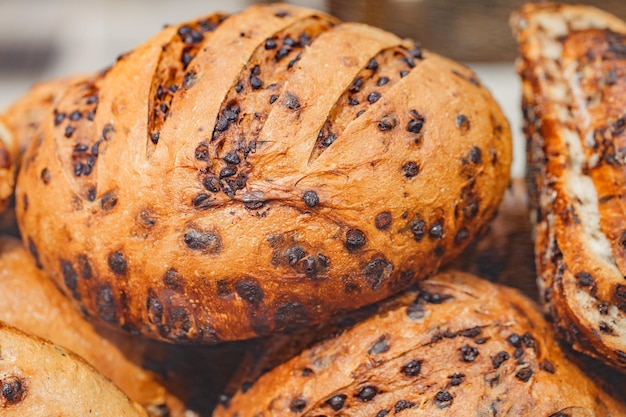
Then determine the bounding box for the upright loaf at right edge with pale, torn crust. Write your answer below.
[511,4,626,372]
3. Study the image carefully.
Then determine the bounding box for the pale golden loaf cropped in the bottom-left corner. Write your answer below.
[0,322,147,417]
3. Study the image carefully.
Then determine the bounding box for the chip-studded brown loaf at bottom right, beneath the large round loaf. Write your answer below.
[213,271,626,417]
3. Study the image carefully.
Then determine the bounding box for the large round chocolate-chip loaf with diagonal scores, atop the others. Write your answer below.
[16,4,511,343]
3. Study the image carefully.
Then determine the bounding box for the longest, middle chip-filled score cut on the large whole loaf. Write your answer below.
[201,15,336,205]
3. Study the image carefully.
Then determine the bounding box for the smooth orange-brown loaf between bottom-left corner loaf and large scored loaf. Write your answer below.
[0,237,244,417]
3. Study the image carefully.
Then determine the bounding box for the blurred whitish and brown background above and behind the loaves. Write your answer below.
[0,0,626,177]
